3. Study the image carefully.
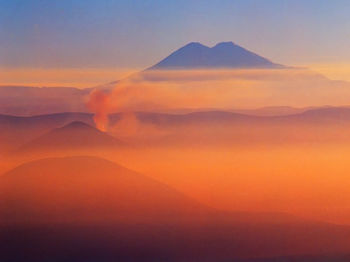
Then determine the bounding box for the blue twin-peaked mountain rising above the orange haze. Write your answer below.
[148,42,284,70]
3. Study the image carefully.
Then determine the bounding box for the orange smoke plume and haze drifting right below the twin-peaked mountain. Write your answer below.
[87,69,350,130]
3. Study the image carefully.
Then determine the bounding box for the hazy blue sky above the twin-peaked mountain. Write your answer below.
[0,0,350,68]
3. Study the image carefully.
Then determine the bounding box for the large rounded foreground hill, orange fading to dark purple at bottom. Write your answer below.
[0,157,350,262]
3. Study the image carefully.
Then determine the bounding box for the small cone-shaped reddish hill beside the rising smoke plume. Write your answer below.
[18,121,123,152]
